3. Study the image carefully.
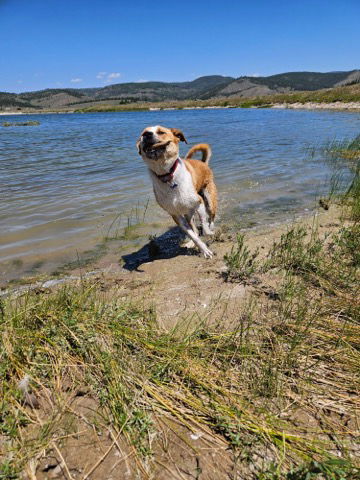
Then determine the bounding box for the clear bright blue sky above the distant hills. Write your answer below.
[0,0,360,92]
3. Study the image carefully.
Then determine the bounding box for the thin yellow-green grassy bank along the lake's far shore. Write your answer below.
[76,84,360,113]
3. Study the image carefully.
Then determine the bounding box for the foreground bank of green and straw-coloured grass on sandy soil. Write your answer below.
[0,140,360,480]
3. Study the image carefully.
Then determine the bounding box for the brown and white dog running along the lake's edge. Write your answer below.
[136,125,217,258]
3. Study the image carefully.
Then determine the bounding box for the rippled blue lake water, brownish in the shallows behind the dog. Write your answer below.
[0,109,360,280]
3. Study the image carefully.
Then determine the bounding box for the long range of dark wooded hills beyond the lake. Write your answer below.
[0,70,360,112]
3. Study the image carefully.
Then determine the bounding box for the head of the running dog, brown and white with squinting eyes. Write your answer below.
[136,125,187,170]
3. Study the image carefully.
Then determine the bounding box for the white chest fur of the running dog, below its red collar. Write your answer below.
[150,160,200,216]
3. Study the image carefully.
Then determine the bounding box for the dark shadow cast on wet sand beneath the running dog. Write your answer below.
[121,227,196,272]
